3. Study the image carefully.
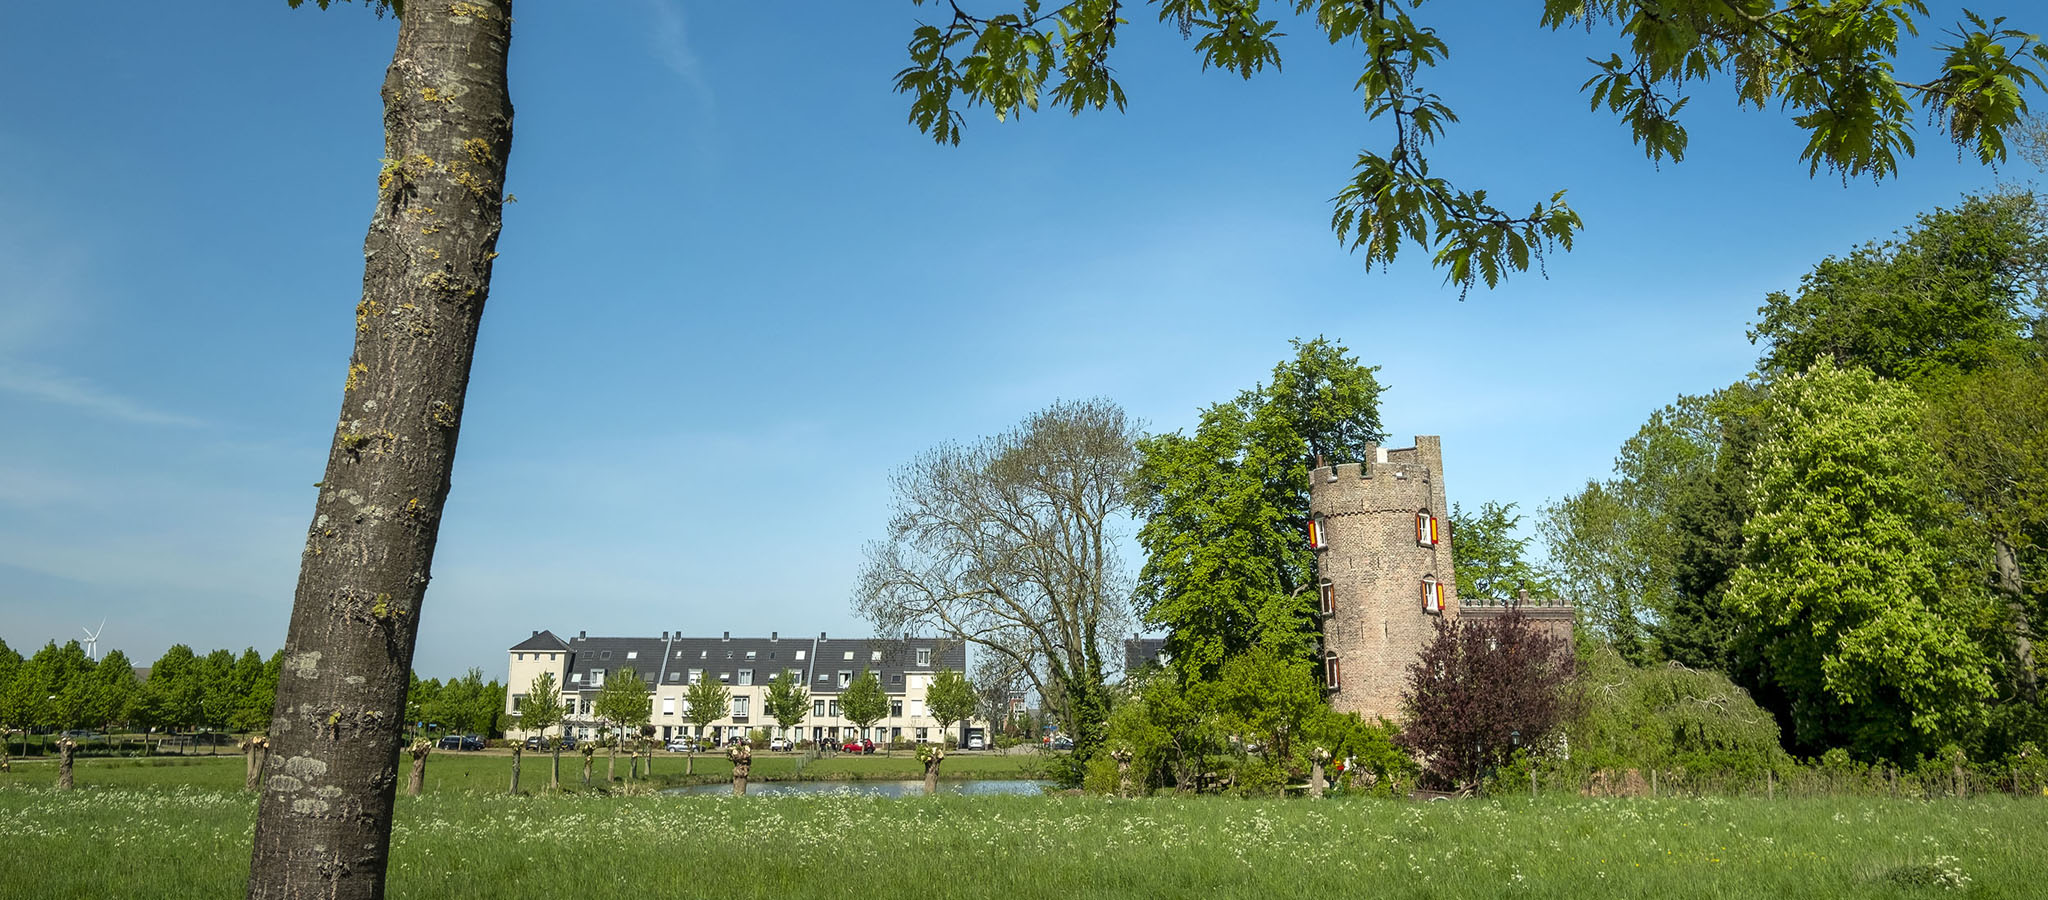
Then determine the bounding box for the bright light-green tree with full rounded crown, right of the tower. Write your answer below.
[1726,357,1999,761]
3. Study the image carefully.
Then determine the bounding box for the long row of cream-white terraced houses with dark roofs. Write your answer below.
[506,631,981,742]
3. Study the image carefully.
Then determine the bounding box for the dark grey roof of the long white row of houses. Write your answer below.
[565,636,967,695]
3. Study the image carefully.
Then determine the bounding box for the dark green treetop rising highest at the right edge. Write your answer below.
[1749,189,2048,383]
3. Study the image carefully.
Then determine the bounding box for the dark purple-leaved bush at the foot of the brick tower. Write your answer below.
[1397,609,1573,787]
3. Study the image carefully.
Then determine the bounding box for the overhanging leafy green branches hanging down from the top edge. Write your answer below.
[897,0,2048,287]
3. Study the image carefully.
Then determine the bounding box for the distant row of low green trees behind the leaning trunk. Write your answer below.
[0,640,504,754]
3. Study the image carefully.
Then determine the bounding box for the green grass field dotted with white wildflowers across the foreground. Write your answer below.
[0,754,2048,900]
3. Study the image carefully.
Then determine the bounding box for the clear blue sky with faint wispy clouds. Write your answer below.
[0,0,2042,677]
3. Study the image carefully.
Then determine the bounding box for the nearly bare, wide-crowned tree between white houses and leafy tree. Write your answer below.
[854,400,1139,756]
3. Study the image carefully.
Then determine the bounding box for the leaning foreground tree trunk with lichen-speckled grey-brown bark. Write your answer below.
[248,0,512,900]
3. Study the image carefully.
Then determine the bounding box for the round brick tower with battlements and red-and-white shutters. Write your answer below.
[1309,435,1458,722]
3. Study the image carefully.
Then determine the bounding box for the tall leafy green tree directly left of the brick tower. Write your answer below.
[1135,338,1382,681]
